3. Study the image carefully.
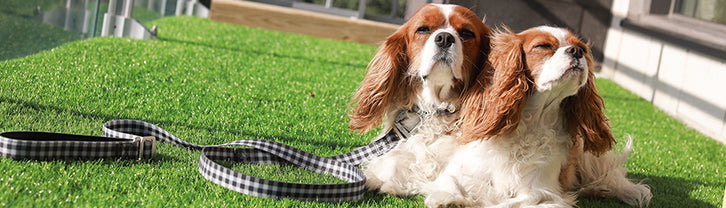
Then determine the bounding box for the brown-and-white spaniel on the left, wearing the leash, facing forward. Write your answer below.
[349,4,491,195]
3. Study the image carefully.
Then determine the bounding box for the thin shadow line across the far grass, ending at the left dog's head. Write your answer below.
[159,37,366,68]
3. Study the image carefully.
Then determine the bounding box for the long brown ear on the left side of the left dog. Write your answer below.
[348,28,408,133]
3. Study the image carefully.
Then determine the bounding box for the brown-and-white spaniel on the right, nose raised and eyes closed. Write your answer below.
[424,26,652,207]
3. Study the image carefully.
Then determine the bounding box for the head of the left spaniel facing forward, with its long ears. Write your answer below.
[349,4,491,132]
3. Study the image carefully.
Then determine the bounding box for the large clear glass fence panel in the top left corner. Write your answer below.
[0,0,91,61]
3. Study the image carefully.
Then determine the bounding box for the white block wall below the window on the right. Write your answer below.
[598,0,726,143]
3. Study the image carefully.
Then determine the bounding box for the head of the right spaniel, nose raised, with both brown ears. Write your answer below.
[462,26,615,154]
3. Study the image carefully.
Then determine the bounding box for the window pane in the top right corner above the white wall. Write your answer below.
[673,0,726,24]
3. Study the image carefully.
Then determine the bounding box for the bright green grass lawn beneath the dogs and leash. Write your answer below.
[0,17,726,207]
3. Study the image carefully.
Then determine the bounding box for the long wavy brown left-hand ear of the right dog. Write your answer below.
[459,27,532,143]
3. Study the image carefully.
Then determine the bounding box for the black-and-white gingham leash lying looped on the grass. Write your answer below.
[0,111,420,202]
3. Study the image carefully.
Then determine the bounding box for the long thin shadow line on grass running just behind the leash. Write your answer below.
[0,96,370,157]
